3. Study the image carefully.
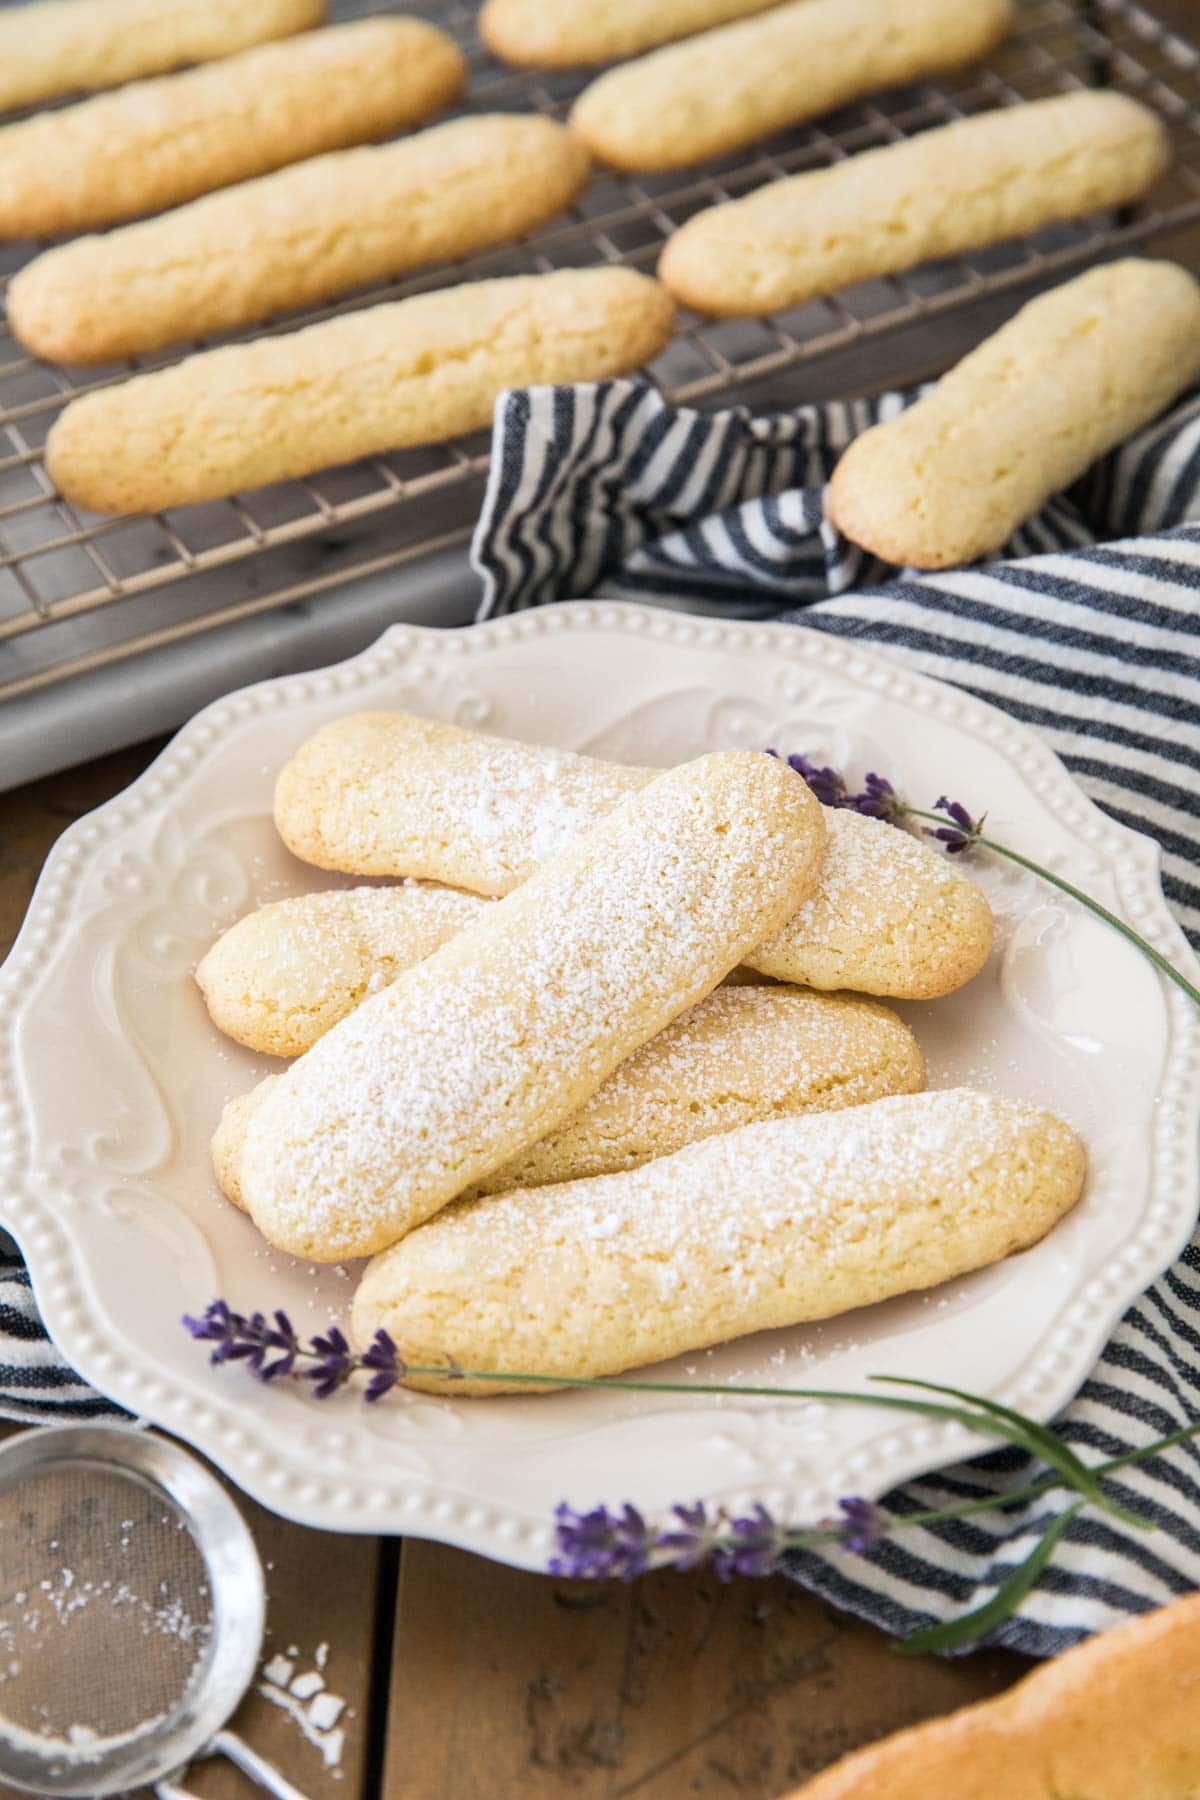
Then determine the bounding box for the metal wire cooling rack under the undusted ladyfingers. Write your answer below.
[0,0,1200,704]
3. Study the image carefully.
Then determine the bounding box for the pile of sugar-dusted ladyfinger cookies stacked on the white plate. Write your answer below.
[196,713,1085,1395]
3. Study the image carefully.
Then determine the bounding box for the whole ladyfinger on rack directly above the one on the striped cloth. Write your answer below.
[662,88,1169,318]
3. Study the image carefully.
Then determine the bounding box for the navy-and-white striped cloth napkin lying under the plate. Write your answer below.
[0,382,1200,1656]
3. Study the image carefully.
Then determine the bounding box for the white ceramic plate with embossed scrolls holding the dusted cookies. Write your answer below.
[0,603,1200,1566]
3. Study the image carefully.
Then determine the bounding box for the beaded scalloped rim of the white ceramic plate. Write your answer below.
[0,599,1200,1568]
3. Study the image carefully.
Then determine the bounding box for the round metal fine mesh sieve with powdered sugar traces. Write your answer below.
[0,1426,314,1800]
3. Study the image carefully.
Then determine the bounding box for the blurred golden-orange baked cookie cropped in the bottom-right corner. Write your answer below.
[790,1593,1200,1800]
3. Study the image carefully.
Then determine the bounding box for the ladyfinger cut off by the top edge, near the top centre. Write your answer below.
[479,0,775,68]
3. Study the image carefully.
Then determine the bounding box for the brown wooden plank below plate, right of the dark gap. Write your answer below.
[383,1541,1027,1800]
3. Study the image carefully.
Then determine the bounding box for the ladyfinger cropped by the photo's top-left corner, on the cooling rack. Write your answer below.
[0,0,326,112]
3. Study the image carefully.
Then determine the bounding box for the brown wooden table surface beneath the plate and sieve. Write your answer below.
[0,743,1024,1800]
